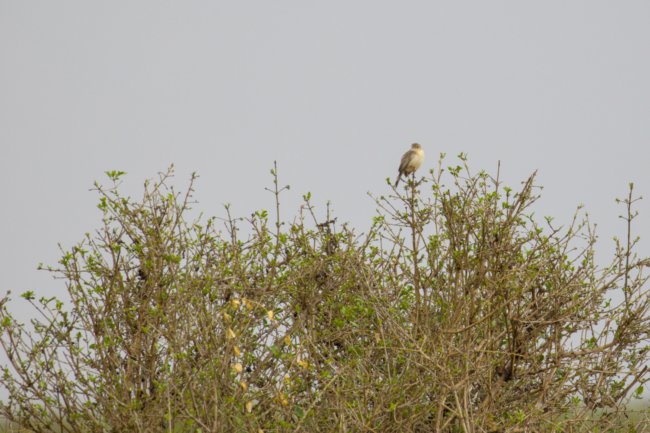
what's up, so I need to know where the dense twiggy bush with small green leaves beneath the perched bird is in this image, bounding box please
[0,156,650,432]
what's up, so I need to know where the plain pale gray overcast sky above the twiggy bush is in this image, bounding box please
[0,0,650,310]
